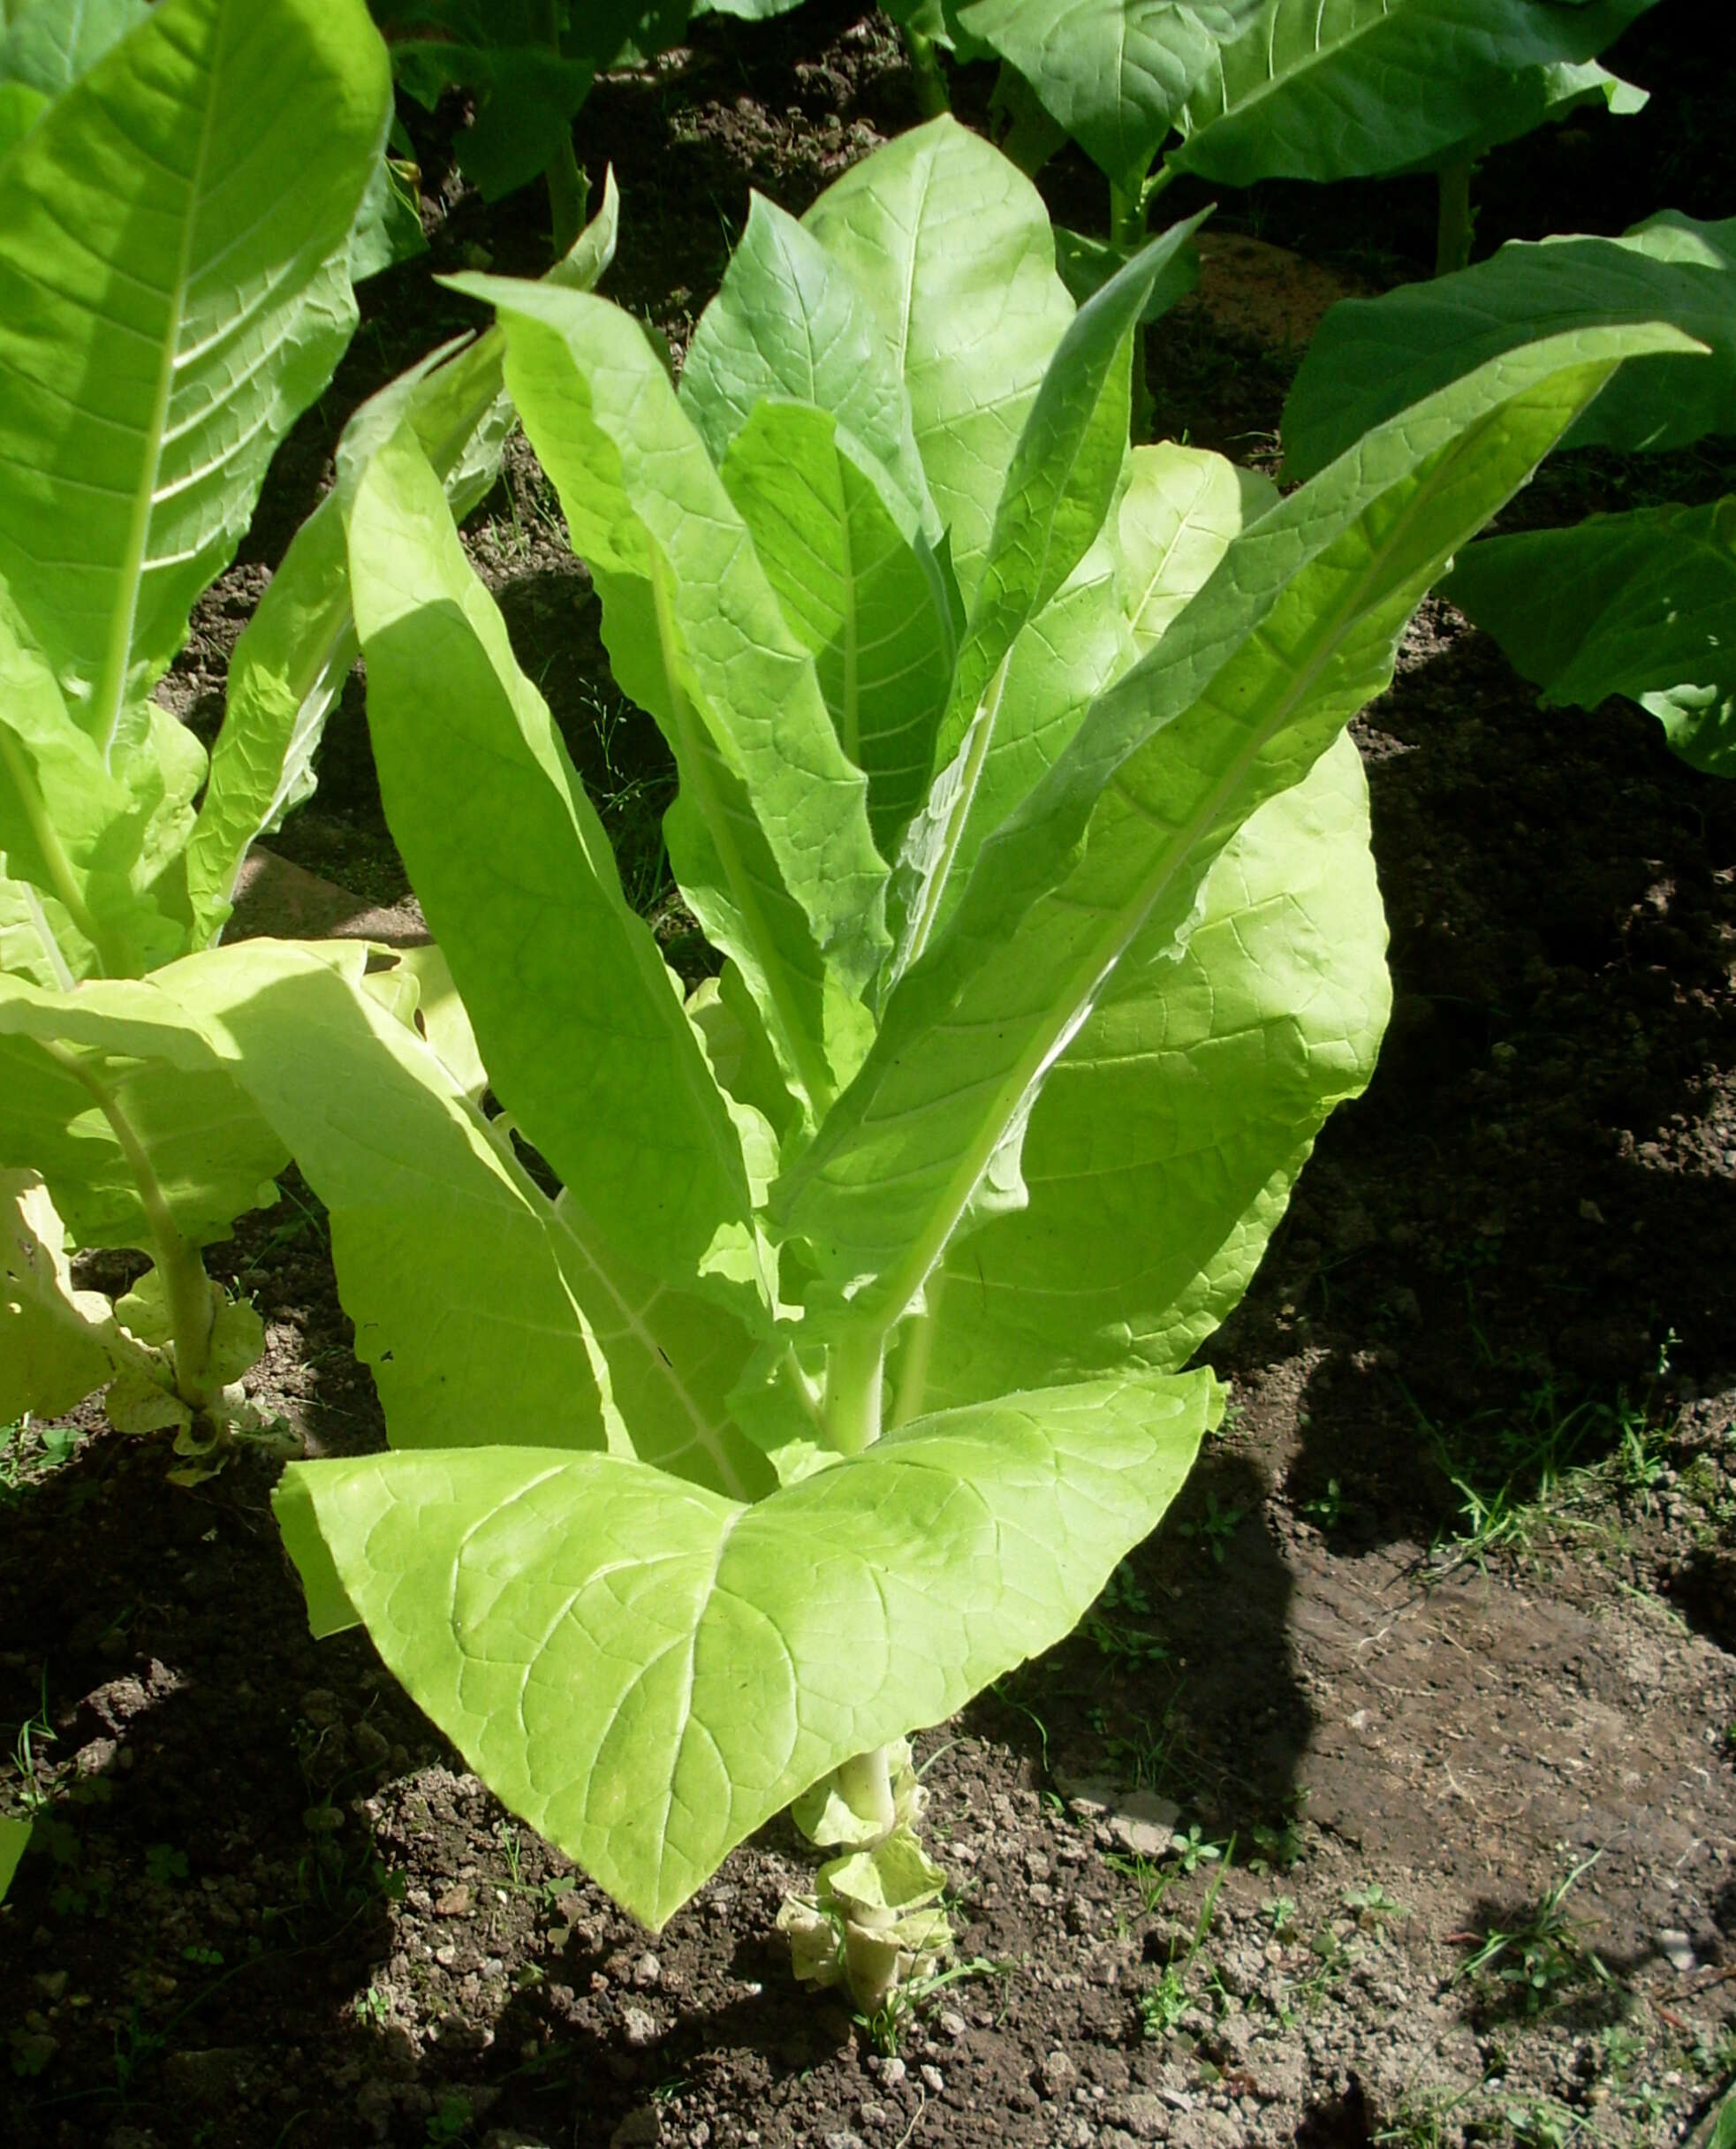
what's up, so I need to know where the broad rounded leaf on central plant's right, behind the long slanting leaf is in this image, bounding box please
[906,740,1390,1409]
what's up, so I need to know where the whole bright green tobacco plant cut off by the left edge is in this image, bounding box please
[0,0,612,1474]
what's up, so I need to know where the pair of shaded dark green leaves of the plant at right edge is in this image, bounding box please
[1283,210,1736,776]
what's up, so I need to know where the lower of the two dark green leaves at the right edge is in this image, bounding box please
[1442,497,1736,776]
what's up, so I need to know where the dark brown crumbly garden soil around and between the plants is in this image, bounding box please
[0,6,1736,2149]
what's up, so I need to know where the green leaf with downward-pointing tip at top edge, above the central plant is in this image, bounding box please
[959,0,1262,194]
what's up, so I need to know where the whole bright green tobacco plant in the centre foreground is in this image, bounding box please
[153,120,1685,2005]
